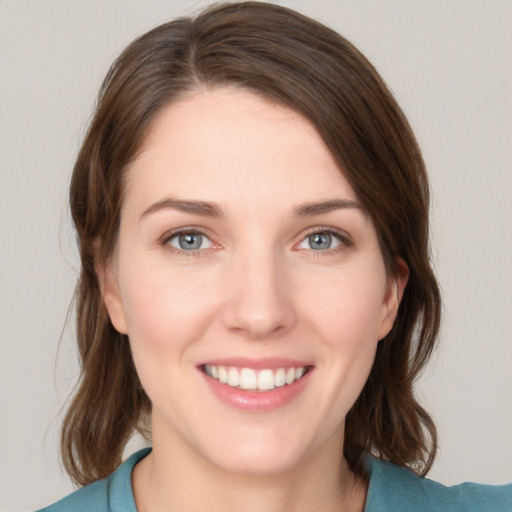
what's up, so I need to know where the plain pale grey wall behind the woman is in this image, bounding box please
[0,0,512,512]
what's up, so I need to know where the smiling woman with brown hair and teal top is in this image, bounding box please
[38,3,512,512]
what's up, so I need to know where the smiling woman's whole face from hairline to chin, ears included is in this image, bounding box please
[102,88,402,473]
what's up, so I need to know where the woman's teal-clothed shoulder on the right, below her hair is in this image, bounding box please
[365,456,512,512]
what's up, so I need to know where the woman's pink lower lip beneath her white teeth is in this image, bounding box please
[200,369,313,412]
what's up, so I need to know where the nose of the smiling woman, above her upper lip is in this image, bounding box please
[223,248,296,340]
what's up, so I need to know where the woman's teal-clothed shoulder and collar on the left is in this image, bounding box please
[33,448,150,512]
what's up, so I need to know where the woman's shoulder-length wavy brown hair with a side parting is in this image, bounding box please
[61,2,441,484]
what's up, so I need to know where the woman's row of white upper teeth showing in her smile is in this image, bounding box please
[204,364,306,391]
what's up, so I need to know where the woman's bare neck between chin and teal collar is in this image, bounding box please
[132,422,367,512]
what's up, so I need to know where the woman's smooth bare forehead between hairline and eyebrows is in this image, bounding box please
[125,87,356,215]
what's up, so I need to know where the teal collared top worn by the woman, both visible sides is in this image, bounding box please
[39,448,512,512]
